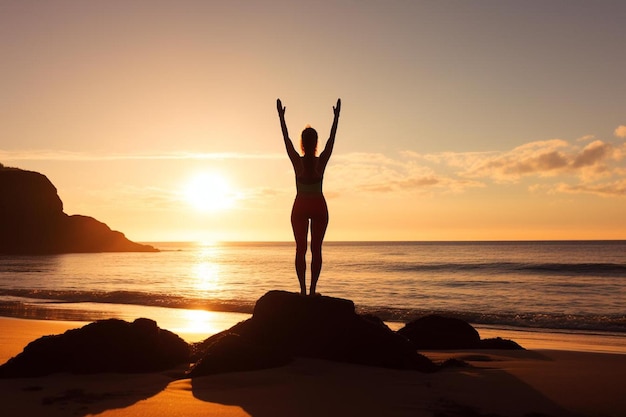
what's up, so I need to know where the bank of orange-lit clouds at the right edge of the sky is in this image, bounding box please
[402,134,626,197]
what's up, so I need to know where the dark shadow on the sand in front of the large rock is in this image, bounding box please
[191,359,571,417]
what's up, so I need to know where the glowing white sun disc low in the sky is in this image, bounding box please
[183,172,236,212]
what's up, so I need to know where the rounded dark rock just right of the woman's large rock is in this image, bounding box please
[398,315,480,349]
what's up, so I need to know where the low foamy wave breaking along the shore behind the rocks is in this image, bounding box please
[0,289,626,336]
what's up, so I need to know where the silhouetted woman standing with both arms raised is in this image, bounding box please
[276,99,341,295]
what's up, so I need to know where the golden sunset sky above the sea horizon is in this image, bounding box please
[0,0,626,242]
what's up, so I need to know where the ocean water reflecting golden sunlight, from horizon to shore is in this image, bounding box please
[0,241,626,352]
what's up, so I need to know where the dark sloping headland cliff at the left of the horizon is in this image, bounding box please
[0,164,157,254]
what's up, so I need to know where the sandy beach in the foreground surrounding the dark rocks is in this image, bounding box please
[0,318,626,417]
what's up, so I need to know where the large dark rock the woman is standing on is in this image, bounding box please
[190,291,437,376]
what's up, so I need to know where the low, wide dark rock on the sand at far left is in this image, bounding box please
[0,319,190,378]
